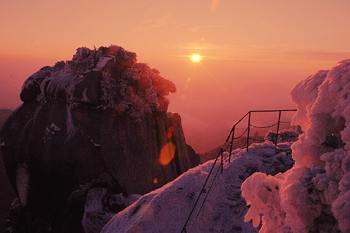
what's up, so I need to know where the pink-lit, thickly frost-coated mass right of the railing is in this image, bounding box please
[242,60,350,233]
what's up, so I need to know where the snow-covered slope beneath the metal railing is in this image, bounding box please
[102,142,293,233]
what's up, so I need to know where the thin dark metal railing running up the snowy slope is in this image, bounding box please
[181,109,297,233]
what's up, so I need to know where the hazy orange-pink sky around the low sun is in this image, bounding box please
[0,0,350,151]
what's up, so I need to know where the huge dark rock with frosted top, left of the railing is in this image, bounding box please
[1,46,199,232]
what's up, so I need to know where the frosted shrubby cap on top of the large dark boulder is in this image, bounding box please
[21,46,176,119]
